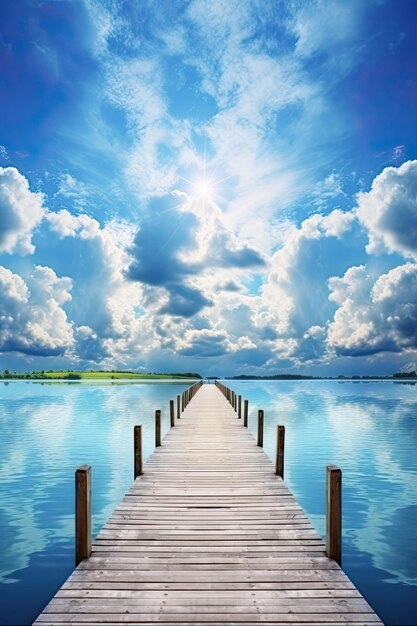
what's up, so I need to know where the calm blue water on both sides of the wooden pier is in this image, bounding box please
[0,381,417,626]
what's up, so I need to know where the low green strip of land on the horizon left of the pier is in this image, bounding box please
[0,369,201,380]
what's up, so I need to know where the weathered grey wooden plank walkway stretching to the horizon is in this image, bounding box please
[35,385,381,626]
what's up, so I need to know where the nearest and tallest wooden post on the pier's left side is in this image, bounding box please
[75,465,91,565]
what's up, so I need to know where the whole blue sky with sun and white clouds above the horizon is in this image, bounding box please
[0,0,417,376]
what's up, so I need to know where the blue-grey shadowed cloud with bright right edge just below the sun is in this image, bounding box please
[128,193,265,317]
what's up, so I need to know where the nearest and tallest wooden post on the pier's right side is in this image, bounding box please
[326,465,342,565]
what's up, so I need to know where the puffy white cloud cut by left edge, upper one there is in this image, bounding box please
[0,167,46,254]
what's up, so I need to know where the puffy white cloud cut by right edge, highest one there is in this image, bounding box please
[357,161,417,259]
